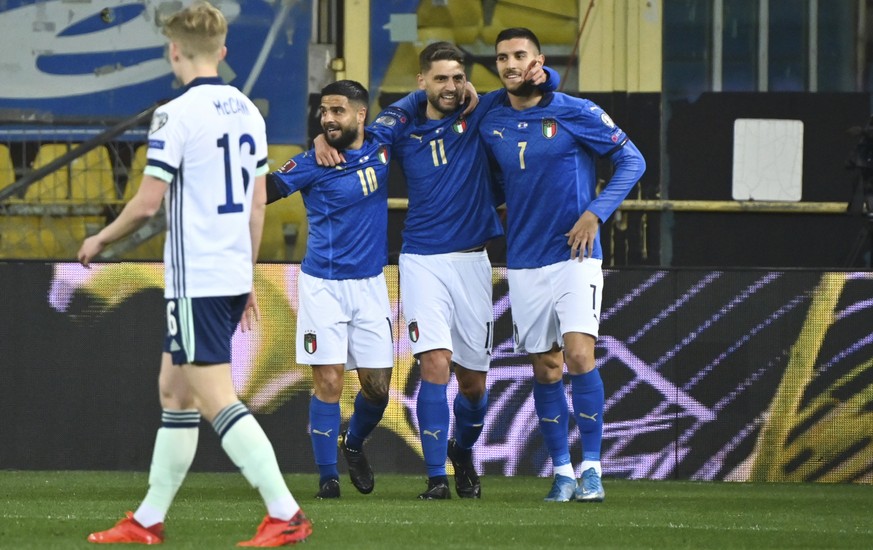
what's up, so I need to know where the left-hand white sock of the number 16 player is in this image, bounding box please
[133,410,200,527]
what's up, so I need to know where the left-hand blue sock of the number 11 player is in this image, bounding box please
[416,380,449,477]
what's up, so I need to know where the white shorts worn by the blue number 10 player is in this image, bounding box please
[296,272,394,370]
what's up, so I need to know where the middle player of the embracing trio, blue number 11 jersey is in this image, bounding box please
[316,42,559,500]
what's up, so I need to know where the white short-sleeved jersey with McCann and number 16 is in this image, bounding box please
[144,77,268,298]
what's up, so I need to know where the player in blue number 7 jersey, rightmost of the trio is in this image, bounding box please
[479,28,645,502]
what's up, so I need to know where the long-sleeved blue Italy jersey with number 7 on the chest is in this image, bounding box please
[479,93,645,269]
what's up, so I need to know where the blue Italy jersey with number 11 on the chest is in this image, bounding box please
[368,92,503,254]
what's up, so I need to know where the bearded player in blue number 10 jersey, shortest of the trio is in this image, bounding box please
[267,80,394,504]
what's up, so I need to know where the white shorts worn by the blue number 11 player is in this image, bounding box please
[399,250,494,371]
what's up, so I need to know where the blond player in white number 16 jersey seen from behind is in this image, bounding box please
[78,2,312,547]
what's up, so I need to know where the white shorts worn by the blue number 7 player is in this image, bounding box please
[507,258,603,353]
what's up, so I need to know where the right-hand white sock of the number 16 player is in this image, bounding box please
[216,405,300,520]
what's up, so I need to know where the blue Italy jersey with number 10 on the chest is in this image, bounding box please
[273,135,389,280]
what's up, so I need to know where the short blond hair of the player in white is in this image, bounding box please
[161,1,227,59]
